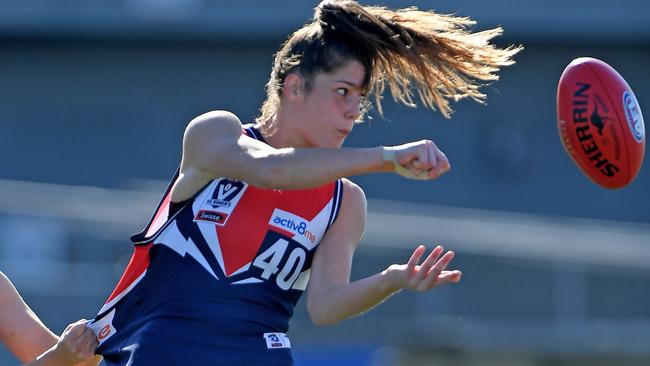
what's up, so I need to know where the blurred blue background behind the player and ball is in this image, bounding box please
[0,0,650,366]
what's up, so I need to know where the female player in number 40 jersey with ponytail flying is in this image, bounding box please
[88,0,519,366]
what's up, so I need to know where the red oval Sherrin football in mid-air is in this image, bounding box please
[557,57,645,189]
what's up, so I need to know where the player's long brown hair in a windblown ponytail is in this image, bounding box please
[257,0,522,127]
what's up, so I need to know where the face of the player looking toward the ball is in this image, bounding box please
[290,60,366,147]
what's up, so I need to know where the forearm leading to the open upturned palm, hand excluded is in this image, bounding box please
[308,271,400,325]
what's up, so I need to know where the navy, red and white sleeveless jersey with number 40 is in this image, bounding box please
[90,125,342,366]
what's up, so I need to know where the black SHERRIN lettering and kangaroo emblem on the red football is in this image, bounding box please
[573,82,620,177]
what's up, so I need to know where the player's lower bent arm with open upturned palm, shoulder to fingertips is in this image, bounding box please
[307,180,461,325]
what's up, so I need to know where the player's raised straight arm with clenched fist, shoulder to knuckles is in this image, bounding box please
[172,111,449,201]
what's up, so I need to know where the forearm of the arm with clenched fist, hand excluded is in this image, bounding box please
[249,147,393,189]
